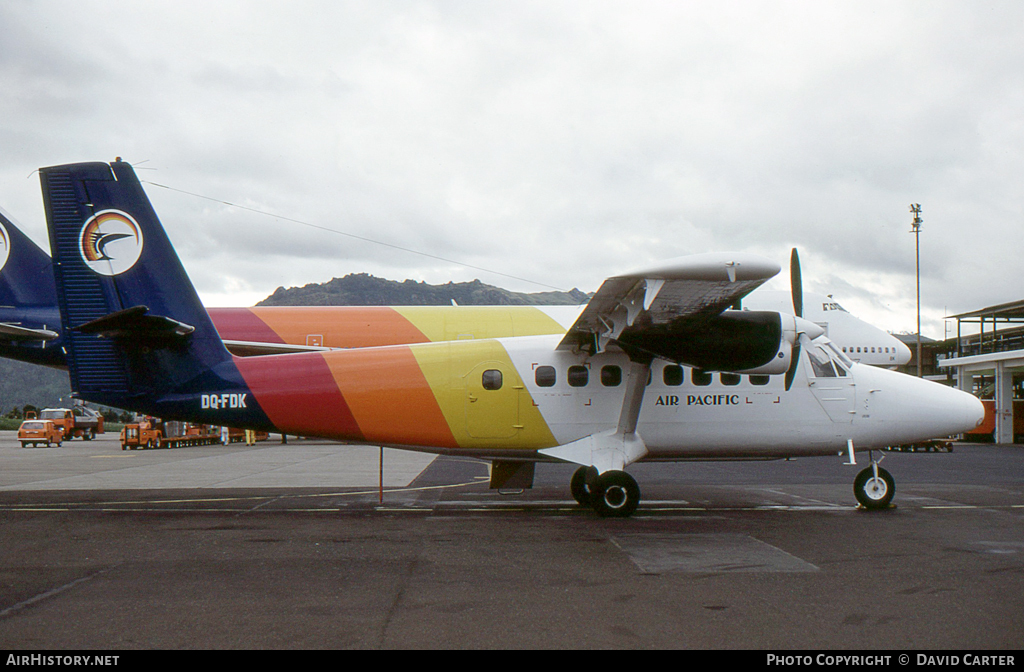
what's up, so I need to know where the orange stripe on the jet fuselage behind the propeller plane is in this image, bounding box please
[242,306,430,347]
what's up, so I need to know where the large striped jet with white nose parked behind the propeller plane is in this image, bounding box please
[0,212,910,367]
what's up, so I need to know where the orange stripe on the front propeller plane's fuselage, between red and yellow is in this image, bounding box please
[323,346,458,448]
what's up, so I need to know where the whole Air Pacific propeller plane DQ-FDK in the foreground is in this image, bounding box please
[41,161,984,516]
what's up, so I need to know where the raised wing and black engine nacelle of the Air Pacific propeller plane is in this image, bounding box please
[558,253,781,369]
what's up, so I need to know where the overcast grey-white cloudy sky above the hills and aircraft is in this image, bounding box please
[0,0,1024,338]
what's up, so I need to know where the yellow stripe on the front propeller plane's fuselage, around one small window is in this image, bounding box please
[411,342,556,451]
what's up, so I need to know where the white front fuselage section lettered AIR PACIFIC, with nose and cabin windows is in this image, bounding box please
[501,336,984,460]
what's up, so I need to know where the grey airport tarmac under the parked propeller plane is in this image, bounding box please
[0,432,1024,661]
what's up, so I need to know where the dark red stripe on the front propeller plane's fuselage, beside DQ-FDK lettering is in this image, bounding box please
[234,352,362,442]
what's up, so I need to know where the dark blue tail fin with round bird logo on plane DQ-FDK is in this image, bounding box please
[40,160,241,417]
